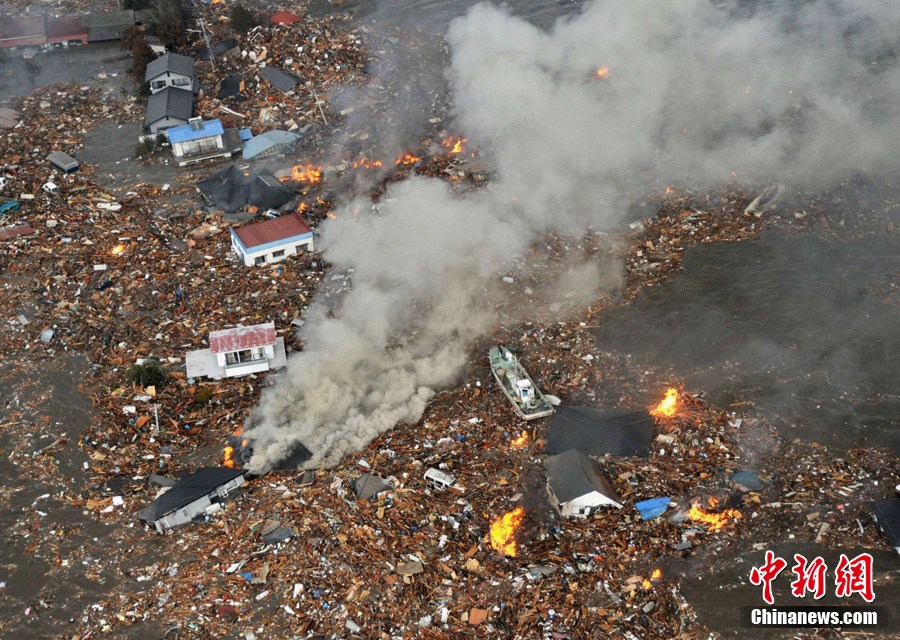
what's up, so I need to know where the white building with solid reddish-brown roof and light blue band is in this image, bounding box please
[231,212,315,267]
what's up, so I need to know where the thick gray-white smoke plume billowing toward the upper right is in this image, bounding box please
[248,0,900,471]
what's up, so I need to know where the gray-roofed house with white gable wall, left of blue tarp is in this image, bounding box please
[546,449,622,518]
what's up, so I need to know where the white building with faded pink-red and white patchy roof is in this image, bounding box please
[185,322,287,380]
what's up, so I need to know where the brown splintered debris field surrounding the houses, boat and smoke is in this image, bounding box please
[0,2,900,639]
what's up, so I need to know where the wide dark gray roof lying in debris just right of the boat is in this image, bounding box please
[544,407,653,456]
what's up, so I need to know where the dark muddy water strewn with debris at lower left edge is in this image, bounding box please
[0,356,160,640]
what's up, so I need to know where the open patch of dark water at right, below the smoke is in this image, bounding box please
[596,233,900,451]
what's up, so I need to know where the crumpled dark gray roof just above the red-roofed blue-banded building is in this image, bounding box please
[197,165,294,211]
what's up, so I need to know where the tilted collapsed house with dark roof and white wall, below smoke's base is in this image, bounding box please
[138,467,245,533]
